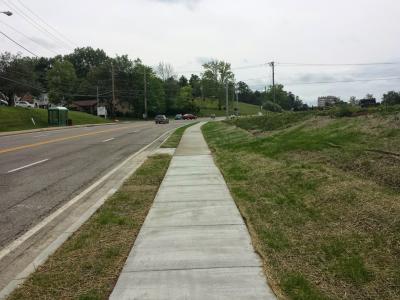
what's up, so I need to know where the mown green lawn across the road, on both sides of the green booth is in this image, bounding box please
[0,106,109,132]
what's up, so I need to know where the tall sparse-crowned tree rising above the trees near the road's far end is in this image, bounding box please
[202,60,235,110]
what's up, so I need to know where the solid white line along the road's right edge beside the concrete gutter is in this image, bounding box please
[0,126,177,260]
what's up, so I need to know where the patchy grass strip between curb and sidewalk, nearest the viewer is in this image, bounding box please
[9,155,171,300]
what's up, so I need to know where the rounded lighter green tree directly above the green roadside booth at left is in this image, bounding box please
[47,60,77,103]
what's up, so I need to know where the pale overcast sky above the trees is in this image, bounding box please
[0,0,400,105]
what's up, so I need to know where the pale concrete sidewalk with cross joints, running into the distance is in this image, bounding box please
[110,123,276,300]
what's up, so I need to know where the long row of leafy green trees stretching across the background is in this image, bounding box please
[0,47,307,117]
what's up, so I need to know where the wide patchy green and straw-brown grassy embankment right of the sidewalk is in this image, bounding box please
[203,109,400,300]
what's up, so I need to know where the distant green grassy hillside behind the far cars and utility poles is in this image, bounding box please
[195,99,265,117]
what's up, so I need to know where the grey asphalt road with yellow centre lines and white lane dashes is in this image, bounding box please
[0,121,192,249]
